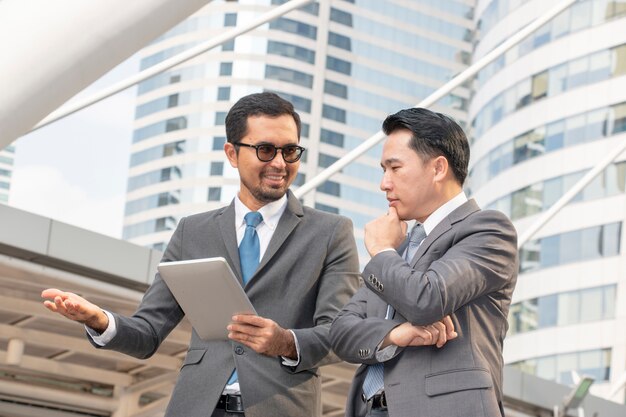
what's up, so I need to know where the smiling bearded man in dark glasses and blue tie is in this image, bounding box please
[42,93,359,417]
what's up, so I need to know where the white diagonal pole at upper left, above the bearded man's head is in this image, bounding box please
[31,0,313,132]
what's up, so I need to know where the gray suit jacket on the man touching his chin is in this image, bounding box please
[330,200,518,417]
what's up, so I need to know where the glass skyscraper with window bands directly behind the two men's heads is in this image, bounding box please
[124,0,473,259]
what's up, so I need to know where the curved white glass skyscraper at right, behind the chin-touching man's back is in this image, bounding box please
[469,0,626,403]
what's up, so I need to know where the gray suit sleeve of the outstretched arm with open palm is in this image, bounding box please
[89,219,185,359]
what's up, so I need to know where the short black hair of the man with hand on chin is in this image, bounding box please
[383,107,470,185]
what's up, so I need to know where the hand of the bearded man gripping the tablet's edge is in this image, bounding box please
[227,314,298,359]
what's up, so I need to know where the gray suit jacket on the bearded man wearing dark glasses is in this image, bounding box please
[91,192,359,417]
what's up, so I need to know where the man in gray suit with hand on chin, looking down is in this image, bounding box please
[330,108,518,417]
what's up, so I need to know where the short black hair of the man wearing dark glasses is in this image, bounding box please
[226,92,301,143]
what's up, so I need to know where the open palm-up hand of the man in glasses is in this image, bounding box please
[41,288,109,333]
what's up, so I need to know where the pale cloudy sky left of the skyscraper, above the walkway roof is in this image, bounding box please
[9,56,139,238]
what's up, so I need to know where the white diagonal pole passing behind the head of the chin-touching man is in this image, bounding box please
[294,0,576,198]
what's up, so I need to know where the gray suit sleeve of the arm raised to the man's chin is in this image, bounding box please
[363,211,518,325]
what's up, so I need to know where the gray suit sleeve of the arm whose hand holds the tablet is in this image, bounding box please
[288,217,359,372]
